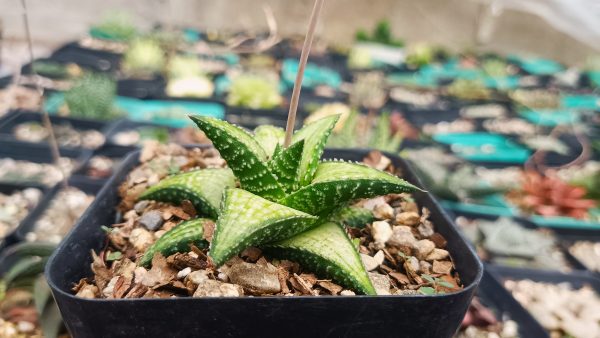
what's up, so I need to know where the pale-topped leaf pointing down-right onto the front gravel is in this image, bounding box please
[262,222,376,295]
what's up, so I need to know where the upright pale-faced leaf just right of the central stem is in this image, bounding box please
[292,115,339,187]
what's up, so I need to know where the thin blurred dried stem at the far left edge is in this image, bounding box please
[21,0,67,186]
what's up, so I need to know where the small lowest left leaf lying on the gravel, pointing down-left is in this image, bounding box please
[138,218,212,266]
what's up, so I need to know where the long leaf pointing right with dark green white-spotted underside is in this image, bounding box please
[279,161,420,215]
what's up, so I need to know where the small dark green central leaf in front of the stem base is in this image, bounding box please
[269,140,304,194]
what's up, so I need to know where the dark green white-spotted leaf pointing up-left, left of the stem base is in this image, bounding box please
[190,116,285,200]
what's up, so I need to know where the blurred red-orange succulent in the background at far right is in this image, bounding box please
[508,171,596,219]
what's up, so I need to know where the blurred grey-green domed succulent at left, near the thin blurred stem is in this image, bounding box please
[65,74,119,120]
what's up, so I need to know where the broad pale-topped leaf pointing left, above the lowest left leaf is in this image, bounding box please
[139,168,235,218]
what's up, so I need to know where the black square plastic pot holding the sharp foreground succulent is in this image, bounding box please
[46,150,483,337]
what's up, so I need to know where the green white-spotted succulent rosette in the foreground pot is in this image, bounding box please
[139,116,418,294]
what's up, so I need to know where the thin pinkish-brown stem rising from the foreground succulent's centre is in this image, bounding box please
[283,0,325,148]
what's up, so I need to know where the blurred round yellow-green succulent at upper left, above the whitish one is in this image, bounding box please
[121,38,166,77]
